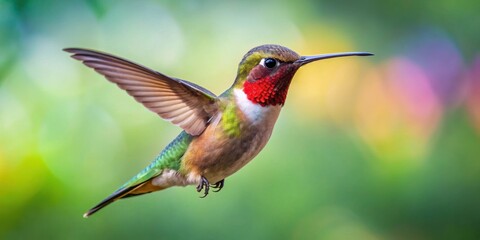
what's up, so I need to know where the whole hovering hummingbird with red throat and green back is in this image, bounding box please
[64,44,373,218]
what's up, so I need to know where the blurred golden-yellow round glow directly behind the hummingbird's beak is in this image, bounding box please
[290,23,372,124]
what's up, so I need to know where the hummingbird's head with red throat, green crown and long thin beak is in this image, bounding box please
[234,44,372,106]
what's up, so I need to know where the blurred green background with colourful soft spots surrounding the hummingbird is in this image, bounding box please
[0,0,480,239]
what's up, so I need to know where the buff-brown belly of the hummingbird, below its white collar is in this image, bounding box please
[183,104,280,183]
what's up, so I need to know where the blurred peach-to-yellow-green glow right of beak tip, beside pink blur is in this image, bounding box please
[355,62,438,172]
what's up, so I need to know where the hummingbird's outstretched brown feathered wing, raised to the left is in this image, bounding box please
[64,48,217,135]
